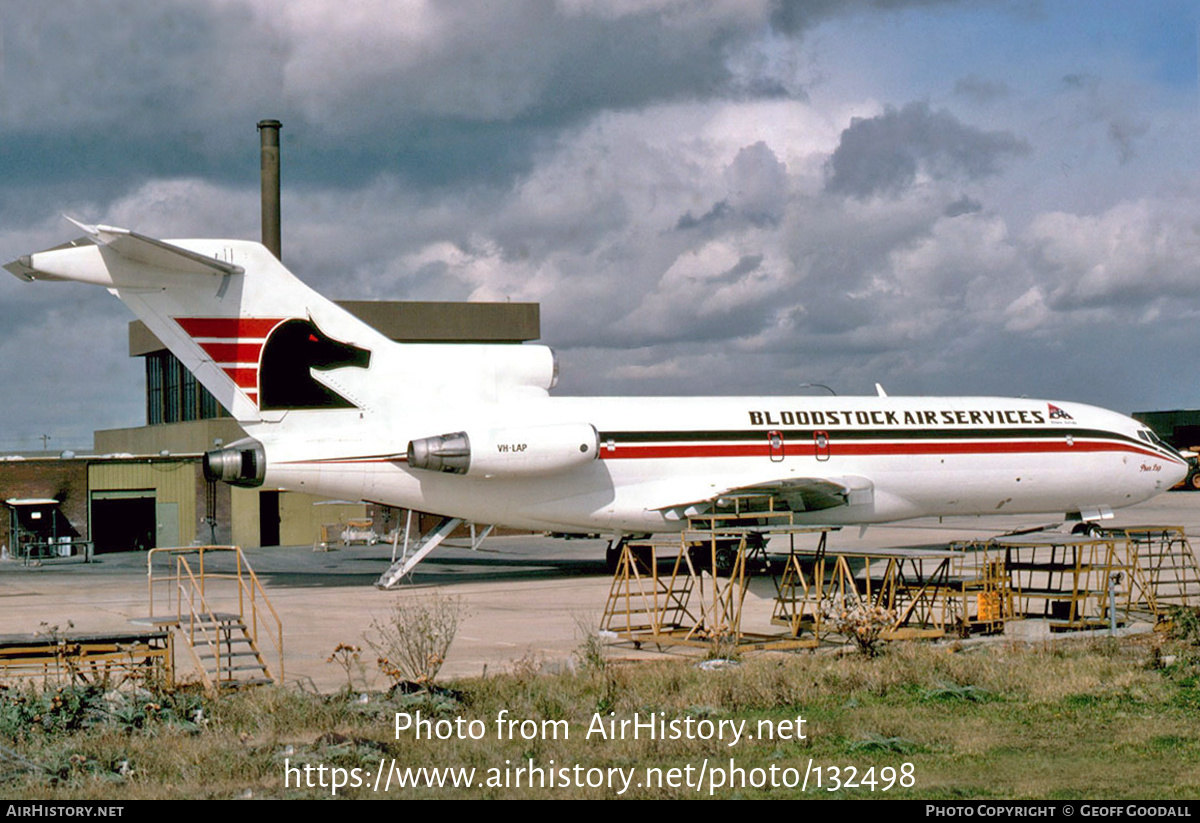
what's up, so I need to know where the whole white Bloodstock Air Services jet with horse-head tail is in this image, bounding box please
[5,223,1187,573]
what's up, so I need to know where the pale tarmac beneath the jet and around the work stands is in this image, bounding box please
[0,492,1200,691]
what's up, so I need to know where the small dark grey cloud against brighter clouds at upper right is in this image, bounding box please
[826,103,1030,198]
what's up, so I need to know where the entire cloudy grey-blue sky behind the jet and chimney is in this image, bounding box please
[0,0,1200,450]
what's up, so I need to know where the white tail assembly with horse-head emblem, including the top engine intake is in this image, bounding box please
[5,218,556,429]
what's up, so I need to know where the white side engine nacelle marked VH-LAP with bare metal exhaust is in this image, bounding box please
[408,423,600,477]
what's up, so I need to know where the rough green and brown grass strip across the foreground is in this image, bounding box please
[0,639,1200,799]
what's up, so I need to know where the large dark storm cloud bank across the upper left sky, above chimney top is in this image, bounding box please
[0,0,806,197]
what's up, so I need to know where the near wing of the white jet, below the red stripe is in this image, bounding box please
[655,475,875,519]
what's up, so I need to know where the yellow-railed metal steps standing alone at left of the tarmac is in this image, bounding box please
[146,546,283,693]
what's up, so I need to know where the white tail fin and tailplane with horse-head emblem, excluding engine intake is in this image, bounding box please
[5,218,391,422]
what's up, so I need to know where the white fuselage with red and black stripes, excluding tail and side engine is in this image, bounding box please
[250,397,1187,533]
